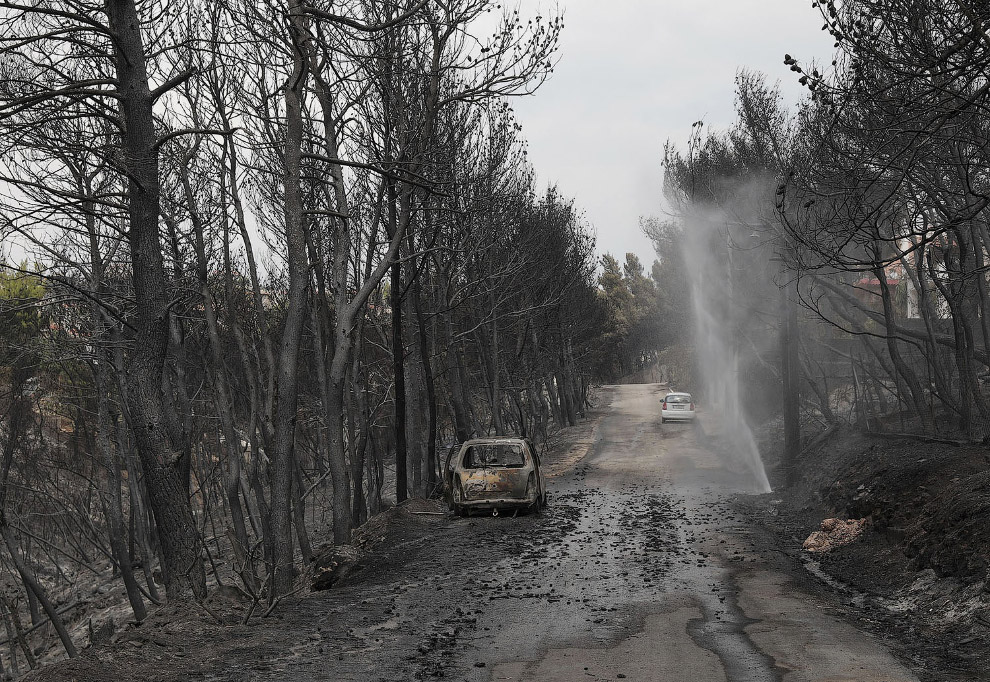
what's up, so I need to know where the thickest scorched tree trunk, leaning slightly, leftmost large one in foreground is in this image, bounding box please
[105,0,206,598]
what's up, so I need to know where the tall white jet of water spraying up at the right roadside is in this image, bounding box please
[678,180,778,493]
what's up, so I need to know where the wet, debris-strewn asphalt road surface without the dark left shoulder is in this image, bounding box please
[486,385,917,682]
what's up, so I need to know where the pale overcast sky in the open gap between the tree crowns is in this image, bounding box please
[513,0,832,269]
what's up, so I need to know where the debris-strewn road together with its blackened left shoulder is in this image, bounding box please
[202,385,917,682]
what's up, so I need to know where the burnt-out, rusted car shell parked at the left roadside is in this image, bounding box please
[444,437,547,515]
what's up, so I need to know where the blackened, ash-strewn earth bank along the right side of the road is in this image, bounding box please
[742,427,990,680]
